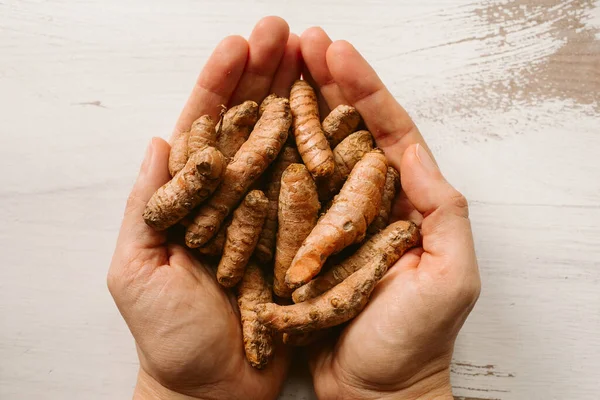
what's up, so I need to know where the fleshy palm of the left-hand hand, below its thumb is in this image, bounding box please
[114,246,285,399]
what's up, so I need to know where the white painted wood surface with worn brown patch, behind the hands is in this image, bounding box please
[0,0,600,400]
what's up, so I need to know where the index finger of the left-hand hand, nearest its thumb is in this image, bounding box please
[173,36,248,142]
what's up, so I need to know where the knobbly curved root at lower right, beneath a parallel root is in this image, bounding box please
[255,254,397,334]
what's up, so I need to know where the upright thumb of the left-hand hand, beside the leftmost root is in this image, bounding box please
[117,138,171,253]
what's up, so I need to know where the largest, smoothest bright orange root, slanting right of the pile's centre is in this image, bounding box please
[285,149,387,289]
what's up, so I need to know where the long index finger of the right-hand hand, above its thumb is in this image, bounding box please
[327,41,429,170]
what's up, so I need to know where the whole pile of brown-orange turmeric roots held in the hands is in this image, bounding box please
[143,80,420,368]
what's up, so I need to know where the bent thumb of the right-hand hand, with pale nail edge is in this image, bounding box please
[401,144,477,268]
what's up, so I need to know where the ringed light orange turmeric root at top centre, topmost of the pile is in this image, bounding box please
[290,80,334,179]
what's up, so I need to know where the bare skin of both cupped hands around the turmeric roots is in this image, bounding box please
[108,17,480,400]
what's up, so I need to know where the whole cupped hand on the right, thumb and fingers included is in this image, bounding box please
[300,28,481,399]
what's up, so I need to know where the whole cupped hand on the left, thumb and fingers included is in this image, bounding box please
[108,17,301,399]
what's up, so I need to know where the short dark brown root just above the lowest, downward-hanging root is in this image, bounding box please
[217,190,269,287]
